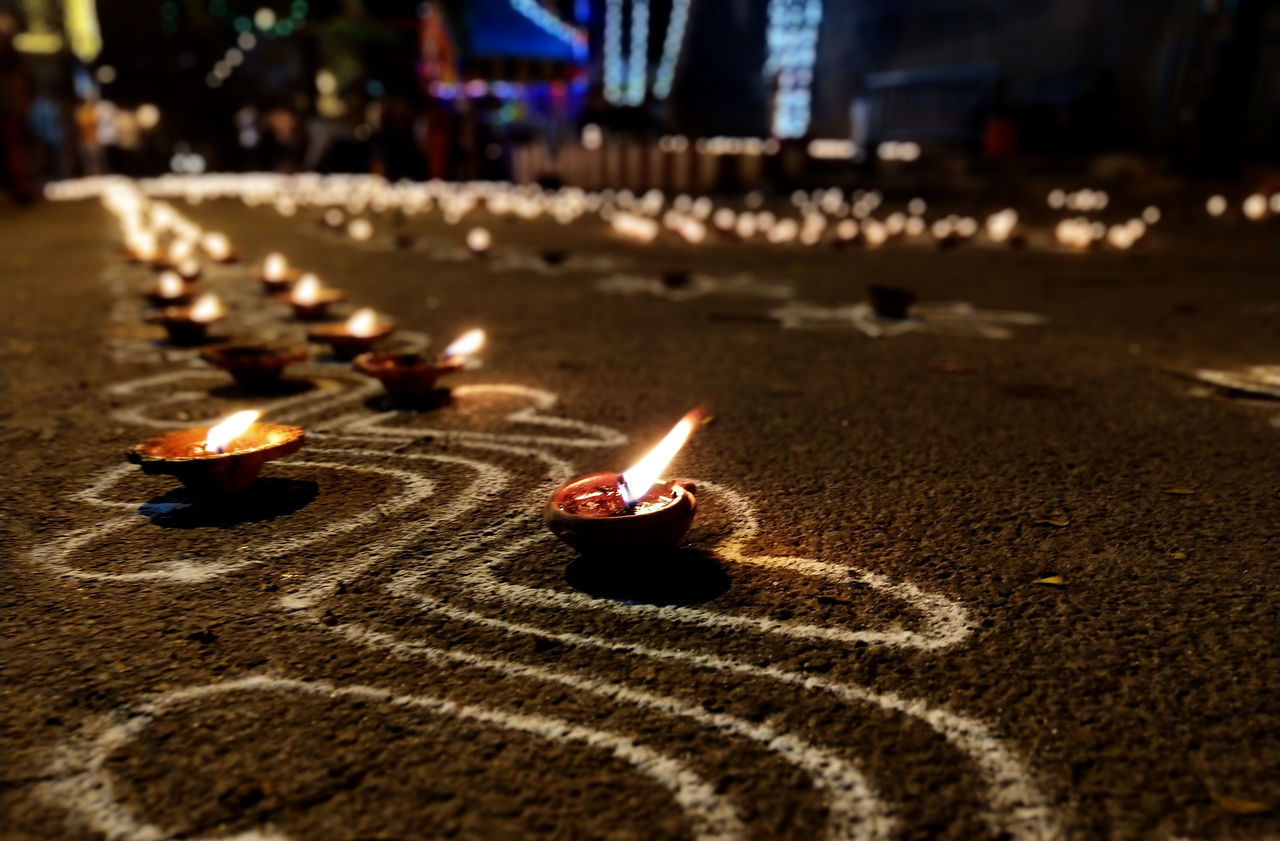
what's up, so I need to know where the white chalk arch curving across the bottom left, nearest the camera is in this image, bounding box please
[41,676,746,841]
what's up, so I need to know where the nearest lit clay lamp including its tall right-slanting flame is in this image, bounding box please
[543,408,703,556]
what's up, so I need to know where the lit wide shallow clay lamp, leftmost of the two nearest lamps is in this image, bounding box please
[128,411,305,497]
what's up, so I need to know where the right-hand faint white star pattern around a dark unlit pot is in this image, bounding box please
[769,301,1044,339]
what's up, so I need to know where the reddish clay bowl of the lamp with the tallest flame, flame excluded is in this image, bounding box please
[543,472,698,554]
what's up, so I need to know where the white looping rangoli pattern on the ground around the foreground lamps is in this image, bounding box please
[31,227,1062,841]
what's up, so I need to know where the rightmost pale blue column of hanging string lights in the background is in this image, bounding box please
[764,0,822,137]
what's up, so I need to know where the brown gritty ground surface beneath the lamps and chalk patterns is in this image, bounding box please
[0,193,1280,841]
